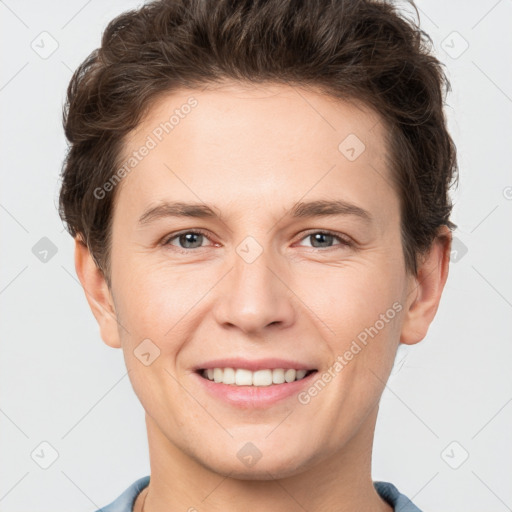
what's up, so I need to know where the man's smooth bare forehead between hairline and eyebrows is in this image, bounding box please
[118,83,394,228]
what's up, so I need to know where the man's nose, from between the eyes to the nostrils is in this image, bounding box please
[214,244,297,335]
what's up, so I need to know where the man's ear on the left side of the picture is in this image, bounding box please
[75,236,121,348]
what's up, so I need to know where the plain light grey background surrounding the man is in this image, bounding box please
[0,0,512,512]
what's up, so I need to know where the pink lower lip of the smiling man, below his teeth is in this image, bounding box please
[194,372,318,409]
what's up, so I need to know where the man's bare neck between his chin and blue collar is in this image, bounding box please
[133,406,393,512]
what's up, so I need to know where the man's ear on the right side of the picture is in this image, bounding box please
[400,226,452,345]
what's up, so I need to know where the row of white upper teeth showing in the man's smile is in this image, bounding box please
[202,368,307,387]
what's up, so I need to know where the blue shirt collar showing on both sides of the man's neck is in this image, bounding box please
[96,476,421,512]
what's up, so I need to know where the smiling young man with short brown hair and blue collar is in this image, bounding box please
[60,0,456,512]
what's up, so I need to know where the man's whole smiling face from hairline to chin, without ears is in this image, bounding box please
[90,84,422,479]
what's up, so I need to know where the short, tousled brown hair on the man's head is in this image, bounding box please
[59,0,458,286]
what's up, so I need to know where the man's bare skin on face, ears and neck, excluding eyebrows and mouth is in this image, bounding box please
[75,83,451,512]
